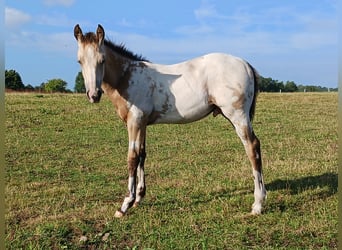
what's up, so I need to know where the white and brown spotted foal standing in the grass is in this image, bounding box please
[74,24,266,218]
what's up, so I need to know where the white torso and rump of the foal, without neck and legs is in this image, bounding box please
[121,53,254,124]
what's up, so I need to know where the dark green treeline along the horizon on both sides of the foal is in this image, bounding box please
[5,69,338,93]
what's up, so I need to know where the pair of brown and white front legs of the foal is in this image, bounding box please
[114,120,146,218]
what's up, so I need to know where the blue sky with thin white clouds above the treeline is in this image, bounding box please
[5,0,338,89]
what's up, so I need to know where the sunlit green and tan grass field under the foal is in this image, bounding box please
[5,93,338,249]
